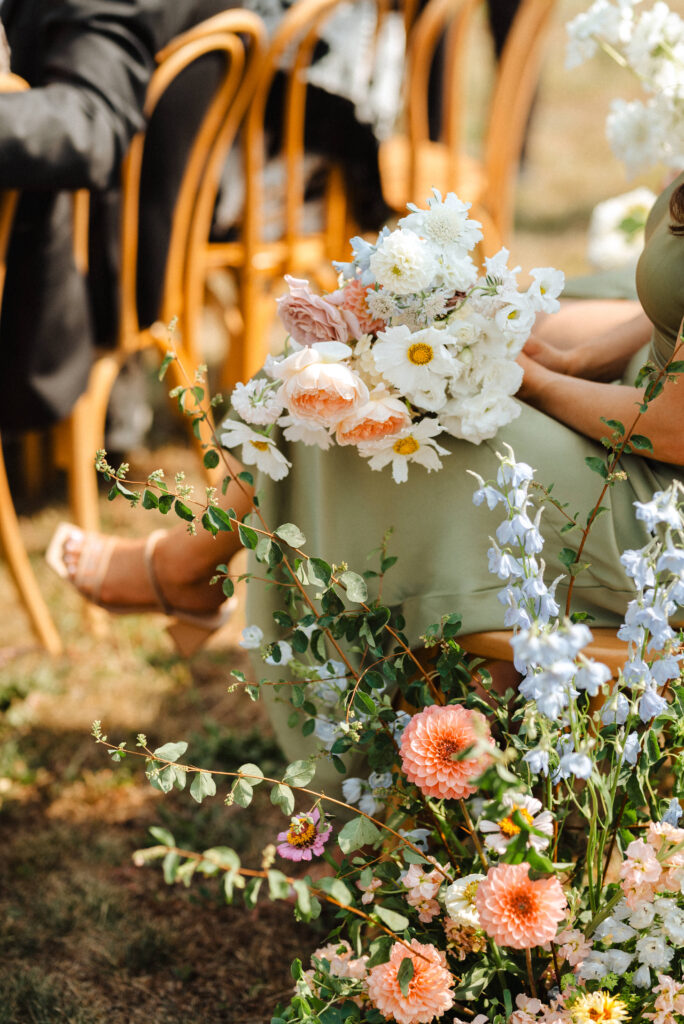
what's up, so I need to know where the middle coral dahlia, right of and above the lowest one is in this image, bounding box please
[475,862,567,949]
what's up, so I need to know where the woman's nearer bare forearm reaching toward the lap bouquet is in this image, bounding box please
[519,359,684,465]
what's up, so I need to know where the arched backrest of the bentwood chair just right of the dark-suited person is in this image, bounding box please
[120,9,264,348]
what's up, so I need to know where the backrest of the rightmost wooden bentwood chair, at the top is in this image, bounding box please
[405,0,554,243]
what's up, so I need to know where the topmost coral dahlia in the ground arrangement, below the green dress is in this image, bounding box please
[399,705,491,800]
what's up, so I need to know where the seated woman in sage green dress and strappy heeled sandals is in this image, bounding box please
[50,174,684,770]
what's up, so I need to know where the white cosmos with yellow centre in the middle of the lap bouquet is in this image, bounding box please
[373,325,458,394]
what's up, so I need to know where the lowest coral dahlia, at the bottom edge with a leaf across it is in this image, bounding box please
[367,939,454,1024]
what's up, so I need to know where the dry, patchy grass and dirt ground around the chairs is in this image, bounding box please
[0,0,658,1024]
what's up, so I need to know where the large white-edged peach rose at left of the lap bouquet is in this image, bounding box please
[277,346,369,427]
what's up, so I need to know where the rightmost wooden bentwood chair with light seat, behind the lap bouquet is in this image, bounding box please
[380,0,554,256]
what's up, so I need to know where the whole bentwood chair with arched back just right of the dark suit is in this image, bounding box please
[57,9,264,529]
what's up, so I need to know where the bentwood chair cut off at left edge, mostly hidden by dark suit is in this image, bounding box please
[0,74,61,654]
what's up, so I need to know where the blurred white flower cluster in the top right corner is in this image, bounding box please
[566,0,684,175]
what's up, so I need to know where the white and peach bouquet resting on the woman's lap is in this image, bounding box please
[221,189,563,483]
